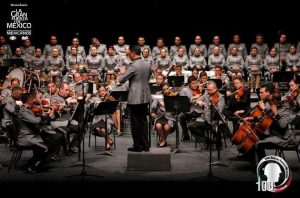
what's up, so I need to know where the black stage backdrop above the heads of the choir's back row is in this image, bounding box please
[0,0,300,51]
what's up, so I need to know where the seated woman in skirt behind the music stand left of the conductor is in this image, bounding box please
[91,85,115,149]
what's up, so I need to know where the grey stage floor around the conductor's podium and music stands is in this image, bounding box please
[0,122,300,195]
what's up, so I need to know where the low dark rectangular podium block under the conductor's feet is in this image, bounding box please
[127,147,171,171]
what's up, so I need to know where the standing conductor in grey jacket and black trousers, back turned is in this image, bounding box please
[119,46,151,152]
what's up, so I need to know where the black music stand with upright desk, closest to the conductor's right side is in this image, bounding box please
[164,96,190,154]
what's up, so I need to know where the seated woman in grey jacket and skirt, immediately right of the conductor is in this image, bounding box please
[151,84,177,147]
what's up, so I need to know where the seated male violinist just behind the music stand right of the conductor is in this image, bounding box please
[179,76,202,141]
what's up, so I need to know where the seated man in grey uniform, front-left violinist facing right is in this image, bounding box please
[17,94,48,174]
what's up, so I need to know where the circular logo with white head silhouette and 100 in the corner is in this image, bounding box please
[256,155,292,192]
